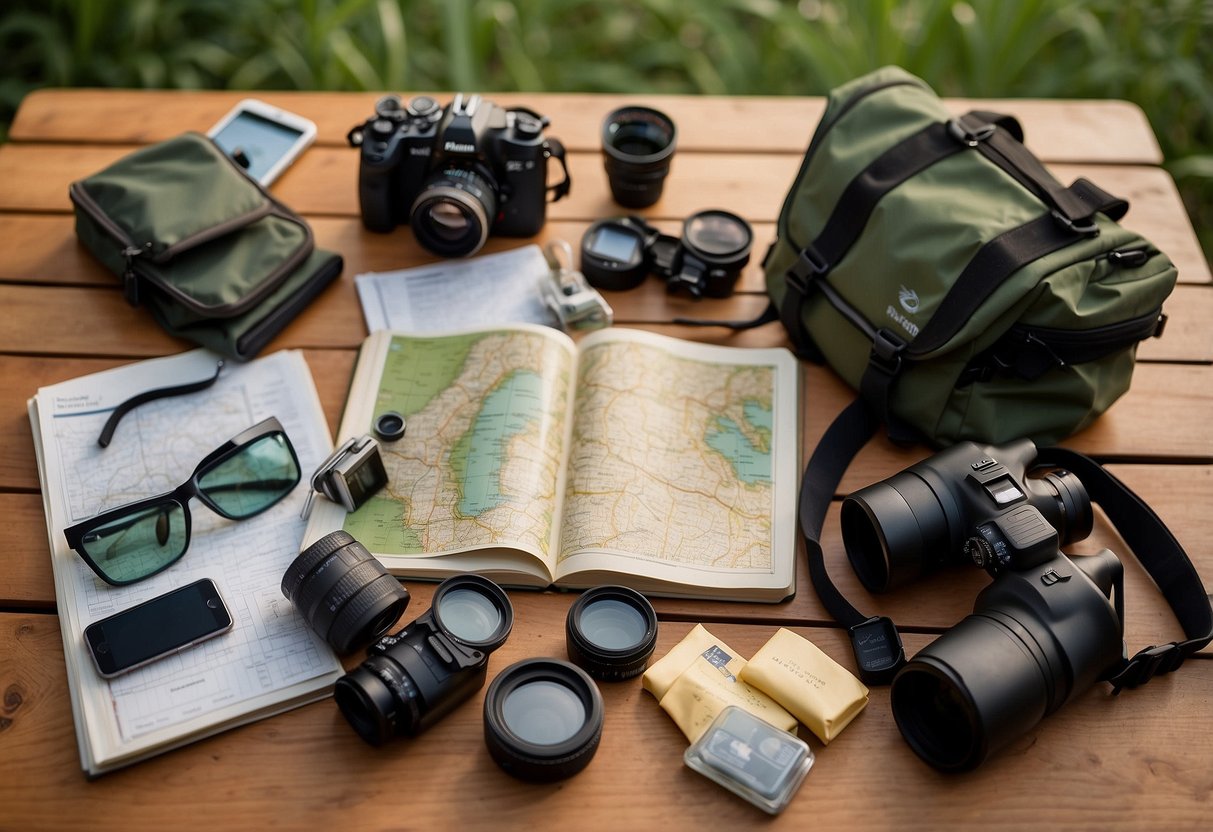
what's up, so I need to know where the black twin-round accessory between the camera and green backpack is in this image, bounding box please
[581,210,753,297]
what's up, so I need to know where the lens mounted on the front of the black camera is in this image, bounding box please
[410,167,497,257]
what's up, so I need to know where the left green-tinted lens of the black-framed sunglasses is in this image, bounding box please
[81,502,187,583]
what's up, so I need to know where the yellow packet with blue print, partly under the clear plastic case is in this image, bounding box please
[643,625,796,742]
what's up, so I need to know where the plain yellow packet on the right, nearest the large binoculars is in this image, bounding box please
[739,628,867,745]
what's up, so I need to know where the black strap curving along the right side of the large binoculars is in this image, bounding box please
[1036,448,1213,694]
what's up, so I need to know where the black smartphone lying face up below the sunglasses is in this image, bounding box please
[84,577,232,679]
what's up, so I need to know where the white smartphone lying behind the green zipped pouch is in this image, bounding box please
[206,98,315,187]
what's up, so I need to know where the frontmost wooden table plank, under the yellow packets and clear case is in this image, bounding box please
[0,613,1213,831]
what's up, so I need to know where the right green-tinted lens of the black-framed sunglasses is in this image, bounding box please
[198,433,300,520]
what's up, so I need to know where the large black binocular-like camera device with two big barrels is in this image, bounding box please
[842,439,1124,771]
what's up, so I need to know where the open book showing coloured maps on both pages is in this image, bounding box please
[304,325,799,602]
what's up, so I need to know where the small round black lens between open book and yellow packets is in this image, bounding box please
[565,587,657,680]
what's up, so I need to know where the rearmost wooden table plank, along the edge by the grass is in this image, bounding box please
[10,90,1162,165]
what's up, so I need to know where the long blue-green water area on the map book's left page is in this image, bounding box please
[459,370,543,517]
